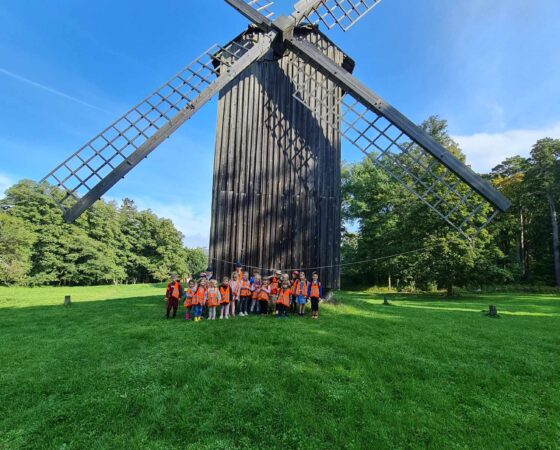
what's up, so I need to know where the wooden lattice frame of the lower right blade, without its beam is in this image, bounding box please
[291,54,499,239]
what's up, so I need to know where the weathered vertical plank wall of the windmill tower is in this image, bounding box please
[209,28,352,288]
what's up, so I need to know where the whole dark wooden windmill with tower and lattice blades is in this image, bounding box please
[42,0,510,288]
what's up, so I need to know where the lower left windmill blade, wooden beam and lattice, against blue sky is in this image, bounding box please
[41,32,276,222]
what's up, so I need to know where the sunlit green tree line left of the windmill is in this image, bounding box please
[0,180,207,285]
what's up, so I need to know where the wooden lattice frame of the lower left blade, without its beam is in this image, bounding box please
[41,39,255,211]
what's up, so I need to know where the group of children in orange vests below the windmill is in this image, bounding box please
[165,264,323,322]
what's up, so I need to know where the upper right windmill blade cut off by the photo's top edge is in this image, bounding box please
[292,0,381,31]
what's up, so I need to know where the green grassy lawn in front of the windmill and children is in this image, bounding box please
[0,285,560,450]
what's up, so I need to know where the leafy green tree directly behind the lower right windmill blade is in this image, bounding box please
[342,117,511,295]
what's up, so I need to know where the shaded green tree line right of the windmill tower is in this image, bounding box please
[342,117,560,294]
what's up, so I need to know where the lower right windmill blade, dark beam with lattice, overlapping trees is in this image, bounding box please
[288,38,511,237]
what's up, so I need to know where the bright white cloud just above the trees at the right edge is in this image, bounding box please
[453,123,560,173]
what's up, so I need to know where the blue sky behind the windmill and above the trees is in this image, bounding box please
[0,0,560,246]
